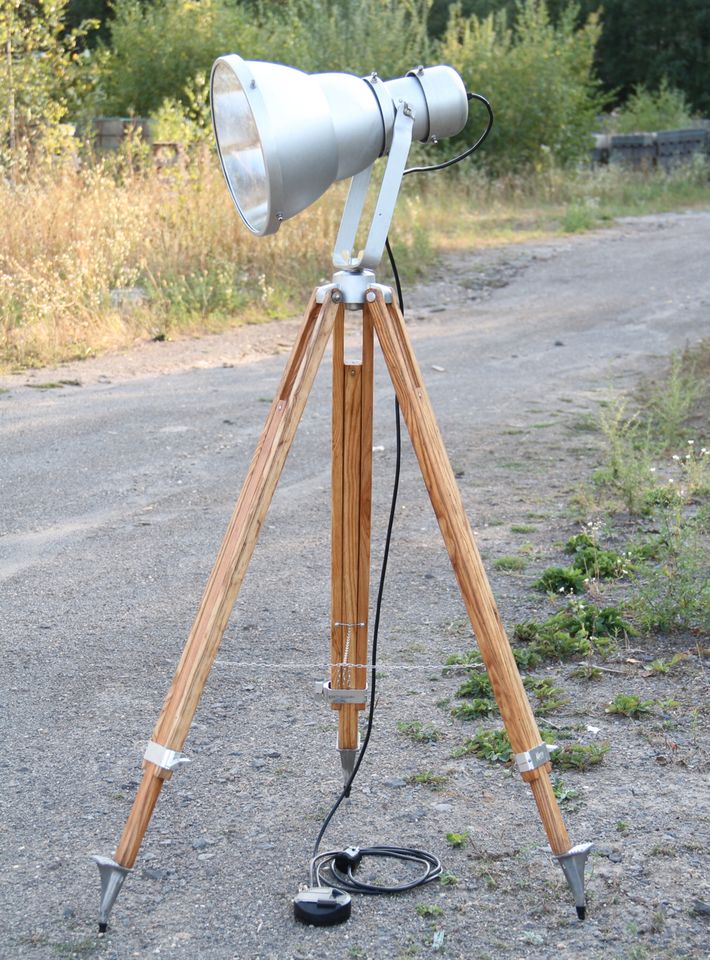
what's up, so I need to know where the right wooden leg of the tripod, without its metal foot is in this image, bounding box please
[365,291,570,855]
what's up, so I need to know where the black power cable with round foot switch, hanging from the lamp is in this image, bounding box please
[304,93,493,924]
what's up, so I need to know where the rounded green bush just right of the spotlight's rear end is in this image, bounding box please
[441,0,603,171]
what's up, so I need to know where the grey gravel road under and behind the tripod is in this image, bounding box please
[0,213,710,960]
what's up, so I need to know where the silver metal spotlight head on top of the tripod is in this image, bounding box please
[210,54,468,236]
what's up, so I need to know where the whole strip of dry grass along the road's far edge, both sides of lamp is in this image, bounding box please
[0,151,707,370]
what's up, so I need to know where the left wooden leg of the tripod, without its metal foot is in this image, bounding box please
[115,296,342,868]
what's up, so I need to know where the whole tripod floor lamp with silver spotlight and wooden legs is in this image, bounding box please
[95,54,591,930]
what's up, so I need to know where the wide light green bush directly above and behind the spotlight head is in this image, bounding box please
[103,0,431,116]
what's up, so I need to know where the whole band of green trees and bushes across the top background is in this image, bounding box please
[0,0,710,173]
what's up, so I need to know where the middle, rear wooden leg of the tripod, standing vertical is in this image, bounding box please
[331,315,373,764]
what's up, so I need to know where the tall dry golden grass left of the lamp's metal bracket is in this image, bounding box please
[0,151,337,368]
